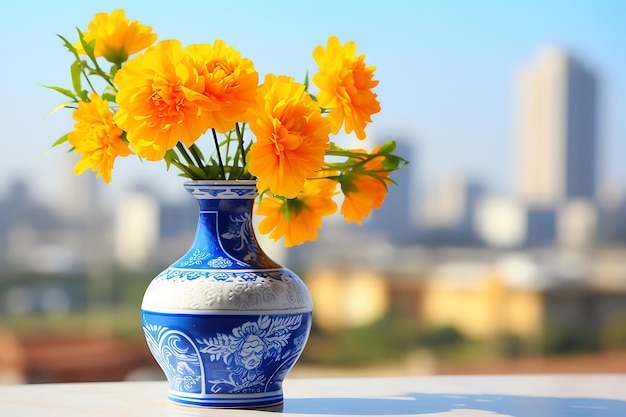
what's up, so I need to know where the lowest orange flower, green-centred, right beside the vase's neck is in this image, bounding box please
[255,179,338,247]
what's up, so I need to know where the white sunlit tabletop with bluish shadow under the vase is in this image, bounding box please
[0,375,626,417]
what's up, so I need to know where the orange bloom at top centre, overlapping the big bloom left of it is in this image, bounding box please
[183,39,259,133]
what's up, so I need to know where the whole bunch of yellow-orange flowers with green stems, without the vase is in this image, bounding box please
[46,10,407,246]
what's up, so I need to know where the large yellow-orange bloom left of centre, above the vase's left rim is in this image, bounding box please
[115,40,208,161]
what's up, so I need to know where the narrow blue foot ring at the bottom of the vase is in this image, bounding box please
[168,392,283,411]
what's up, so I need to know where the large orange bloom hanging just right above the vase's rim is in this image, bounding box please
[248,74,330,198]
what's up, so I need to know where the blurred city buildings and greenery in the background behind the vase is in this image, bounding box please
[0,47,626,382]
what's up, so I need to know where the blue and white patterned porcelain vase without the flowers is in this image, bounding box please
[141,181,312,408]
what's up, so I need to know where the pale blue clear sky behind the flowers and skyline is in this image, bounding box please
[0,0,626,203]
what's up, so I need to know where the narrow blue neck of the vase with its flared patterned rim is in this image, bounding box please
[172,181,280,270]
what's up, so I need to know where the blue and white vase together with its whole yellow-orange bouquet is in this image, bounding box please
[44,10,407,407]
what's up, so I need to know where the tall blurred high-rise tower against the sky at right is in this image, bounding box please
[517,47,598,208]
